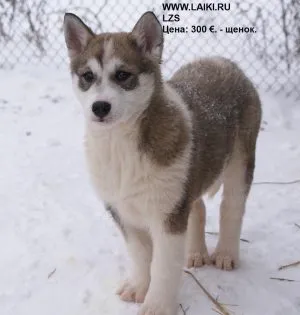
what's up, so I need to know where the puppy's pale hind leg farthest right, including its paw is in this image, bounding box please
[211,150,254,270]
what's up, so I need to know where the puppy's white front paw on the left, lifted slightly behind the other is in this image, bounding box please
[116,280,149,303]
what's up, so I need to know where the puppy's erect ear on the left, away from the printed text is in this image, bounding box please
[64,13,94,58]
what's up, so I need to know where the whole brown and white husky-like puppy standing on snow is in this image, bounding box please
[64,12,261,315]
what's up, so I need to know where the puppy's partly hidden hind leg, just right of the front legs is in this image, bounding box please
[187,199,210,268]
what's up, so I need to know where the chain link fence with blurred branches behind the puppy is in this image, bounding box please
[0,0,300,99]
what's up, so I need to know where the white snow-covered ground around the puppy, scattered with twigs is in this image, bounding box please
[0,68,300,315]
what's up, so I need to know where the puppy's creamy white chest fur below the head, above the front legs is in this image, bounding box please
[86,121,189,227]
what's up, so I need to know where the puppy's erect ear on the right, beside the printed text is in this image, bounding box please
[132,11,164,62]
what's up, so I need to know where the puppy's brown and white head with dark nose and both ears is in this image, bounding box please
[64,12,163,126]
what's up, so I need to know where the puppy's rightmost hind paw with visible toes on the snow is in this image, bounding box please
[211,248,239,270]
